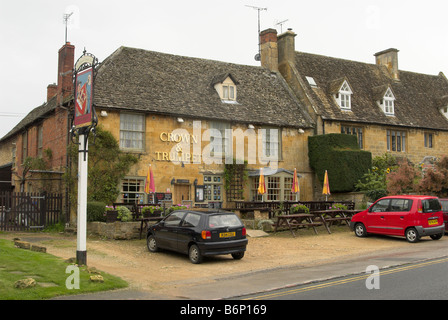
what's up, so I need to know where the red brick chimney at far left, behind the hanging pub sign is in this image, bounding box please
[57,42,75,104]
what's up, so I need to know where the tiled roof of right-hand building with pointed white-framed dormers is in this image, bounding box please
[295,52,448,130]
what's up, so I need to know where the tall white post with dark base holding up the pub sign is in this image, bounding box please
[76,134,88,265]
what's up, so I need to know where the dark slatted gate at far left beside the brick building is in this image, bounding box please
[0,192,62,231]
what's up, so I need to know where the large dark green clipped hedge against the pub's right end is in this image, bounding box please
[308,133,372,193]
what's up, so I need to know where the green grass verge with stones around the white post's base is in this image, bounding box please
[0,239,128,300]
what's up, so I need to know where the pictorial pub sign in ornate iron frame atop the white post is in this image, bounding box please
[73,51,98,129]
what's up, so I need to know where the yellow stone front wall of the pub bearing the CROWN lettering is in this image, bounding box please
[97,110,314,205]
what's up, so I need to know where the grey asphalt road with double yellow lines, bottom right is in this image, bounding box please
[242,258,448,300]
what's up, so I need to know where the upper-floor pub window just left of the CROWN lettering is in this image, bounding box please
[120,113,145,151]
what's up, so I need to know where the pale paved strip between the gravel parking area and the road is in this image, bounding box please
[57,238,448,300]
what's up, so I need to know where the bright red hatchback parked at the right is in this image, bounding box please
[350,195,445,242]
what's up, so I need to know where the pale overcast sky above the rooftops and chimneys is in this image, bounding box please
[0,0,448,137]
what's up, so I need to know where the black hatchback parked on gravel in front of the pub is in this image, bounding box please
[146,210,247,263]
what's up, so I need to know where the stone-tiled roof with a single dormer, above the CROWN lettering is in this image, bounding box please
[94,47,313,128]
